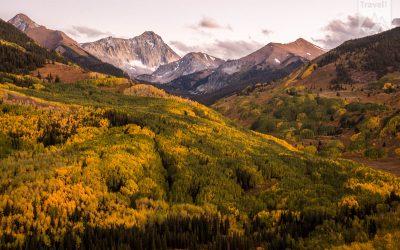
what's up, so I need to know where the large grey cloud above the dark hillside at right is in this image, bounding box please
[313,16,384,49]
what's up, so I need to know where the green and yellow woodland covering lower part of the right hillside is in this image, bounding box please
[248,90,400,159]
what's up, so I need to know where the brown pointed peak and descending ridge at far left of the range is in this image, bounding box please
[8,14,124,76]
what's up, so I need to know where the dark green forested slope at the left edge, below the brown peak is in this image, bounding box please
[0,19,66,74]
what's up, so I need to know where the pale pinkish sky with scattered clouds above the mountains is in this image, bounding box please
[0,0,400,59]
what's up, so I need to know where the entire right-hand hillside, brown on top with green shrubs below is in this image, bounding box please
[214,28,400,175]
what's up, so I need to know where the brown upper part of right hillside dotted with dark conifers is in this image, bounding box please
[293,27,400,90]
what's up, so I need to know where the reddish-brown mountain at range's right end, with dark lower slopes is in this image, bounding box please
[156,38,325,103]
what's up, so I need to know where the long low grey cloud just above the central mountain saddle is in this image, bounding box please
[170,40,263,60]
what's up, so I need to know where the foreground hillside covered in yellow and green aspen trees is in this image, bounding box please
[0,77,400,249]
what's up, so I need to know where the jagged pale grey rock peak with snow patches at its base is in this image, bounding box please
[82,31,180,77]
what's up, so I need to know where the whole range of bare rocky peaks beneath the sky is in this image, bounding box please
[9,14,325,103]
